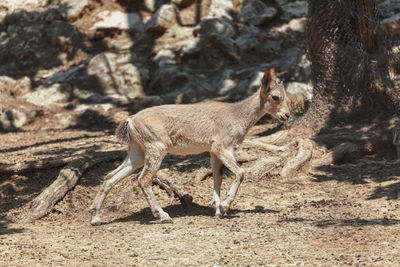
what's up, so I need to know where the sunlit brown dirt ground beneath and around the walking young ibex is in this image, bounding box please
[0,113,400,266]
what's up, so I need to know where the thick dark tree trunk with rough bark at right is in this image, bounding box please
[301,0,400,131]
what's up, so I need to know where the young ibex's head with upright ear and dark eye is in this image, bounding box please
[260,68,290,121]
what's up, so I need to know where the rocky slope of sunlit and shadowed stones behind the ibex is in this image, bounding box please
[0,0,400,131]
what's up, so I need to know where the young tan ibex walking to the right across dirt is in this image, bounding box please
[90,68,289,225]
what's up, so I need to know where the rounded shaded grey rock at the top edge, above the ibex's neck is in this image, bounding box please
[238,0,278,25]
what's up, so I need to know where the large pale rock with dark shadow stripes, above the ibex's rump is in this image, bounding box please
[87,52,149,99]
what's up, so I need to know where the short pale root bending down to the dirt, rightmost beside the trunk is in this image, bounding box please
[280,139,314,178]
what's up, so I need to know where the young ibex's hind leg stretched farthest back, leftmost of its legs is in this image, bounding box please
[89,143,144,225]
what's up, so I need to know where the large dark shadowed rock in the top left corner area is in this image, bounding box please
[0,9,84,77]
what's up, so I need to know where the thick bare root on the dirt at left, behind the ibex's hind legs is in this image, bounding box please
[23,151,125,222]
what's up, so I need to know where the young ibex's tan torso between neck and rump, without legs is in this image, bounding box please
[131,102,242,154]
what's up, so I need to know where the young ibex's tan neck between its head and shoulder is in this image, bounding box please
[234,90,266,133]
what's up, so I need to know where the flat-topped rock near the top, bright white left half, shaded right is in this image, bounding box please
[90,10,144,32]
